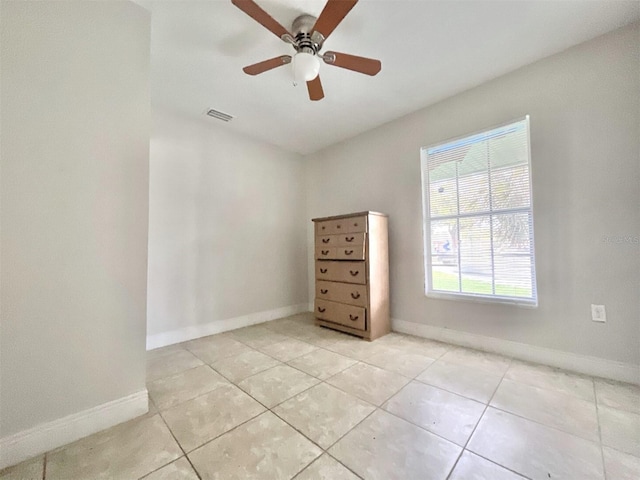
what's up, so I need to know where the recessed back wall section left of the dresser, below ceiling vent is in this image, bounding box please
[147,109,307,348]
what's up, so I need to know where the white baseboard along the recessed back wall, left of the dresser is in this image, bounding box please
[147,303,309,350]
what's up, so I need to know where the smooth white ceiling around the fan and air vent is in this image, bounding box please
[137,0,640,154]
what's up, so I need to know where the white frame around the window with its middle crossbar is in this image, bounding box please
[420,115,538,308]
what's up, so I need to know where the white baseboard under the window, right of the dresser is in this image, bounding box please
[391,318,640,384]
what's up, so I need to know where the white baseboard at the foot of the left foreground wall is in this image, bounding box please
[0,389,149,470]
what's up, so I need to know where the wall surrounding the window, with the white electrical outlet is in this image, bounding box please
[307,24,640,365]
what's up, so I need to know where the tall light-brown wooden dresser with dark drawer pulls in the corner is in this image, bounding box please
[313,212,391,340]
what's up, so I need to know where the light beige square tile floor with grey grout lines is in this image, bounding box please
[0,314,640,480]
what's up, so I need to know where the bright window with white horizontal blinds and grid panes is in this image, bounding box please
[421,116,537,305]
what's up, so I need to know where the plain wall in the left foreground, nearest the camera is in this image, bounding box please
[0,1,150,442]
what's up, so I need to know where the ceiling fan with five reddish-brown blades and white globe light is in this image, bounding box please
[231,0,382,100]
